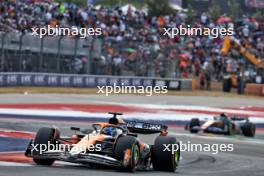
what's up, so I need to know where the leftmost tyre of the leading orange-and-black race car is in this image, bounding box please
[32,127,60,165]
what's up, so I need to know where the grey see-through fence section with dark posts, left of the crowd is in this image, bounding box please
[0,32,96,73]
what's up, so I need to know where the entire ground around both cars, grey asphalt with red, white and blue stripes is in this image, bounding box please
[0,94,264,176]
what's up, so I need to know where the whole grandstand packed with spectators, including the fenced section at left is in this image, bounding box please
[0,1,264,92]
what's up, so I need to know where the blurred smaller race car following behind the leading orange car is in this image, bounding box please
[185,113,256,137]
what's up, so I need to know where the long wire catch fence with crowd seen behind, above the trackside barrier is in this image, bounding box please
[0,31,180,78]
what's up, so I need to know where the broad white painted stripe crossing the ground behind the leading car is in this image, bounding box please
[0,108,264,123]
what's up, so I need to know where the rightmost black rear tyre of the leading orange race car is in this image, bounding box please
[151,136,180,172]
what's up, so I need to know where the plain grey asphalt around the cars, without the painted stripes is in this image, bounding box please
[0,94,264,176]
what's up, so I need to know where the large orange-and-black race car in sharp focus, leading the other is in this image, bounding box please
[25,113,180,172]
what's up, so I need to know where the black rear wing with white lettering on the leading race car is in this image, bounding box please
[126,121,168,134]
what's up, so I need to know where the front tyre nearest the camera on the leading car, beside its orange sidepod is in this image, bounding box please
[115,136,140,172]
